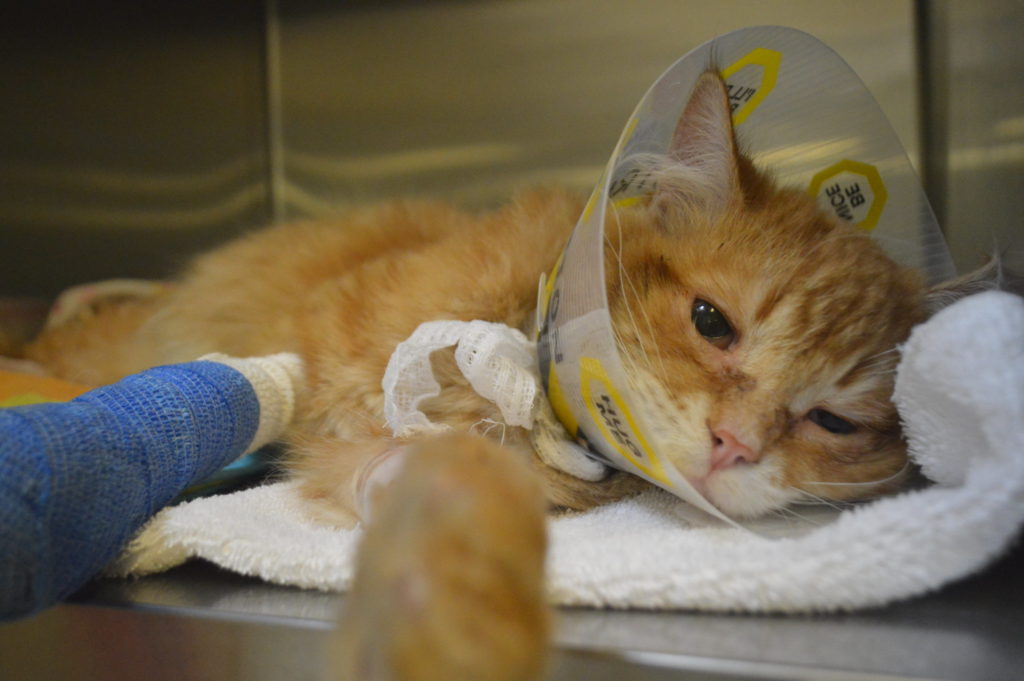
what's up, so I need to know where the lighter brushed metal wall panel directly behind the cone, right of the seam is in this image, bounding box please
[276,0,918,216]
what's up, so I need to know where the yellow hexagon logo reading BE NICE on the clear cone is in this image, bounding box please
[808,159,889,231]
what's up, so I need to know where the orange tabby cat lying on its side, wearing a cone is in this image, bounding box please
[19,73,970,679]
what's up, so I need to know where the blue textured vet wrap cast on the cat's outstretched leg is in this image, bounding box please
[0,361,259,619]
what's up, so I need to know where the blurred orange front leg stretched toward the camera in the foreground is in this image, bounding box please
[331,434,550,681]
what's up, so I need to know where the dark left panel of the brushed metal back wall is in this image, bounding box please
[0,0,268,296]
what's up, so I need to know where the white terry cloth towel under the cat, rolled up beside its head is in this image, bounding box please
[108,292,1024,612]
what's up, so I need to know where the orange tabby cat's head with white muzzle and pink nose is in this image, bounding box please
[605,72,950,516]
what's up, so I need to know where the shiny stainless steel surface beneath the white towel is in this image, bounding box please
[0,536,1024,681]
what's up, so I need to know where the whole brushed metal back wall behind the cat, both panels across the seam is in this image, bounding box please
[0,0,916,296]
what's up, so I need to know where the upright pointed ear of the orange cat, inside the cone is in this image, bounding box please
[654,71,741,214]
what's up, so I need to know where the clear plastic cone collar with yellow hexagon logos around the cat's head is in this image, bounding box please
[538,27,954,524]
